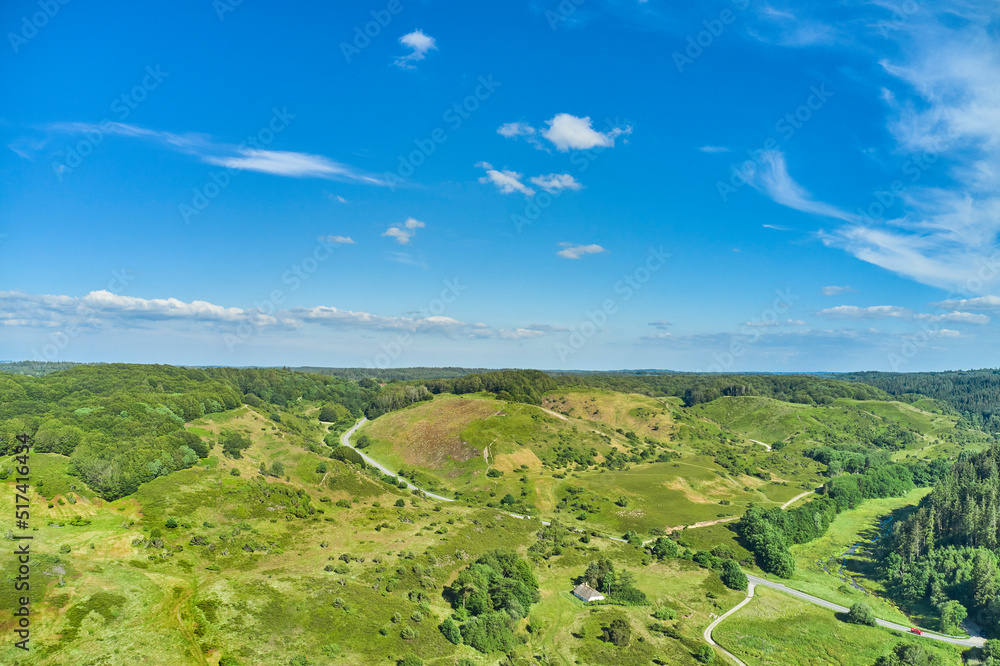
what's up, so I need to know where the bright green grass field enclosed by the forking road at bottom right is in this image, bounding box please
[712,587,962,666]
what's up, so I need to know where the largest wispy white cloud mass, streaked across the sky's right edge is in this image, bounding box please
[753,0,1000,294]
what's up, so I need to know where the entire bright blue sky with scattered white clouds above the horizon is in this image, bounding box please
[0,0,1000,372]
